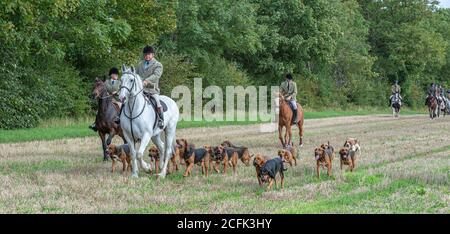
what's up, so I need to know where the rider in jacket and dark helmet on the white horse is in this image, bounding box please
[116,45,164,129]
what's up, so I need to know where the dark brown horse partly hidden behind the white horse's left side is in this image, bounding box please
[92,79,126,161]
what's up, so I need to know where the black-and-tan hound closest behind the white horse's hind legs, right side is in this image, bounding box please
[183,144,211,177]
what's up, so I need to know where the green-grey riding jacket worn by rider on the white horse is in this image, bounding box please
[136,59,163,94]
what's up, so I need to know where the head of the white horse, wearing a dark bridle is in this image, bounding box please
[119,65,143,102]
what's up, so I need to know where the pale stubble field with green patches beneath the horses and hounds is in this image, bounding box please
[0,115,450,214]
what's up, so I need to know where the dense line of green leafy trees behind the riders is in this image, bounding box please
[0,0,450,129]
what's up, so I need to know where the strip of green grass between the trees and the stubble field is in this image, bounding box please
[0,109,425,143]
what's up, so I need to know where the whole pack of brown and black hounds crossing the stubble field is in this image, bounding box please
[107,138,361,190]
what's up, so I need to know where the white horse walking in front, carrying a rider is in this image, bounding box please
[119,65,180,178]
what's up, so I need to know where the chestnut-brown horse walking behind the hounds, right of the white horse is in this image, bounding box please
[278,95,304,147]
